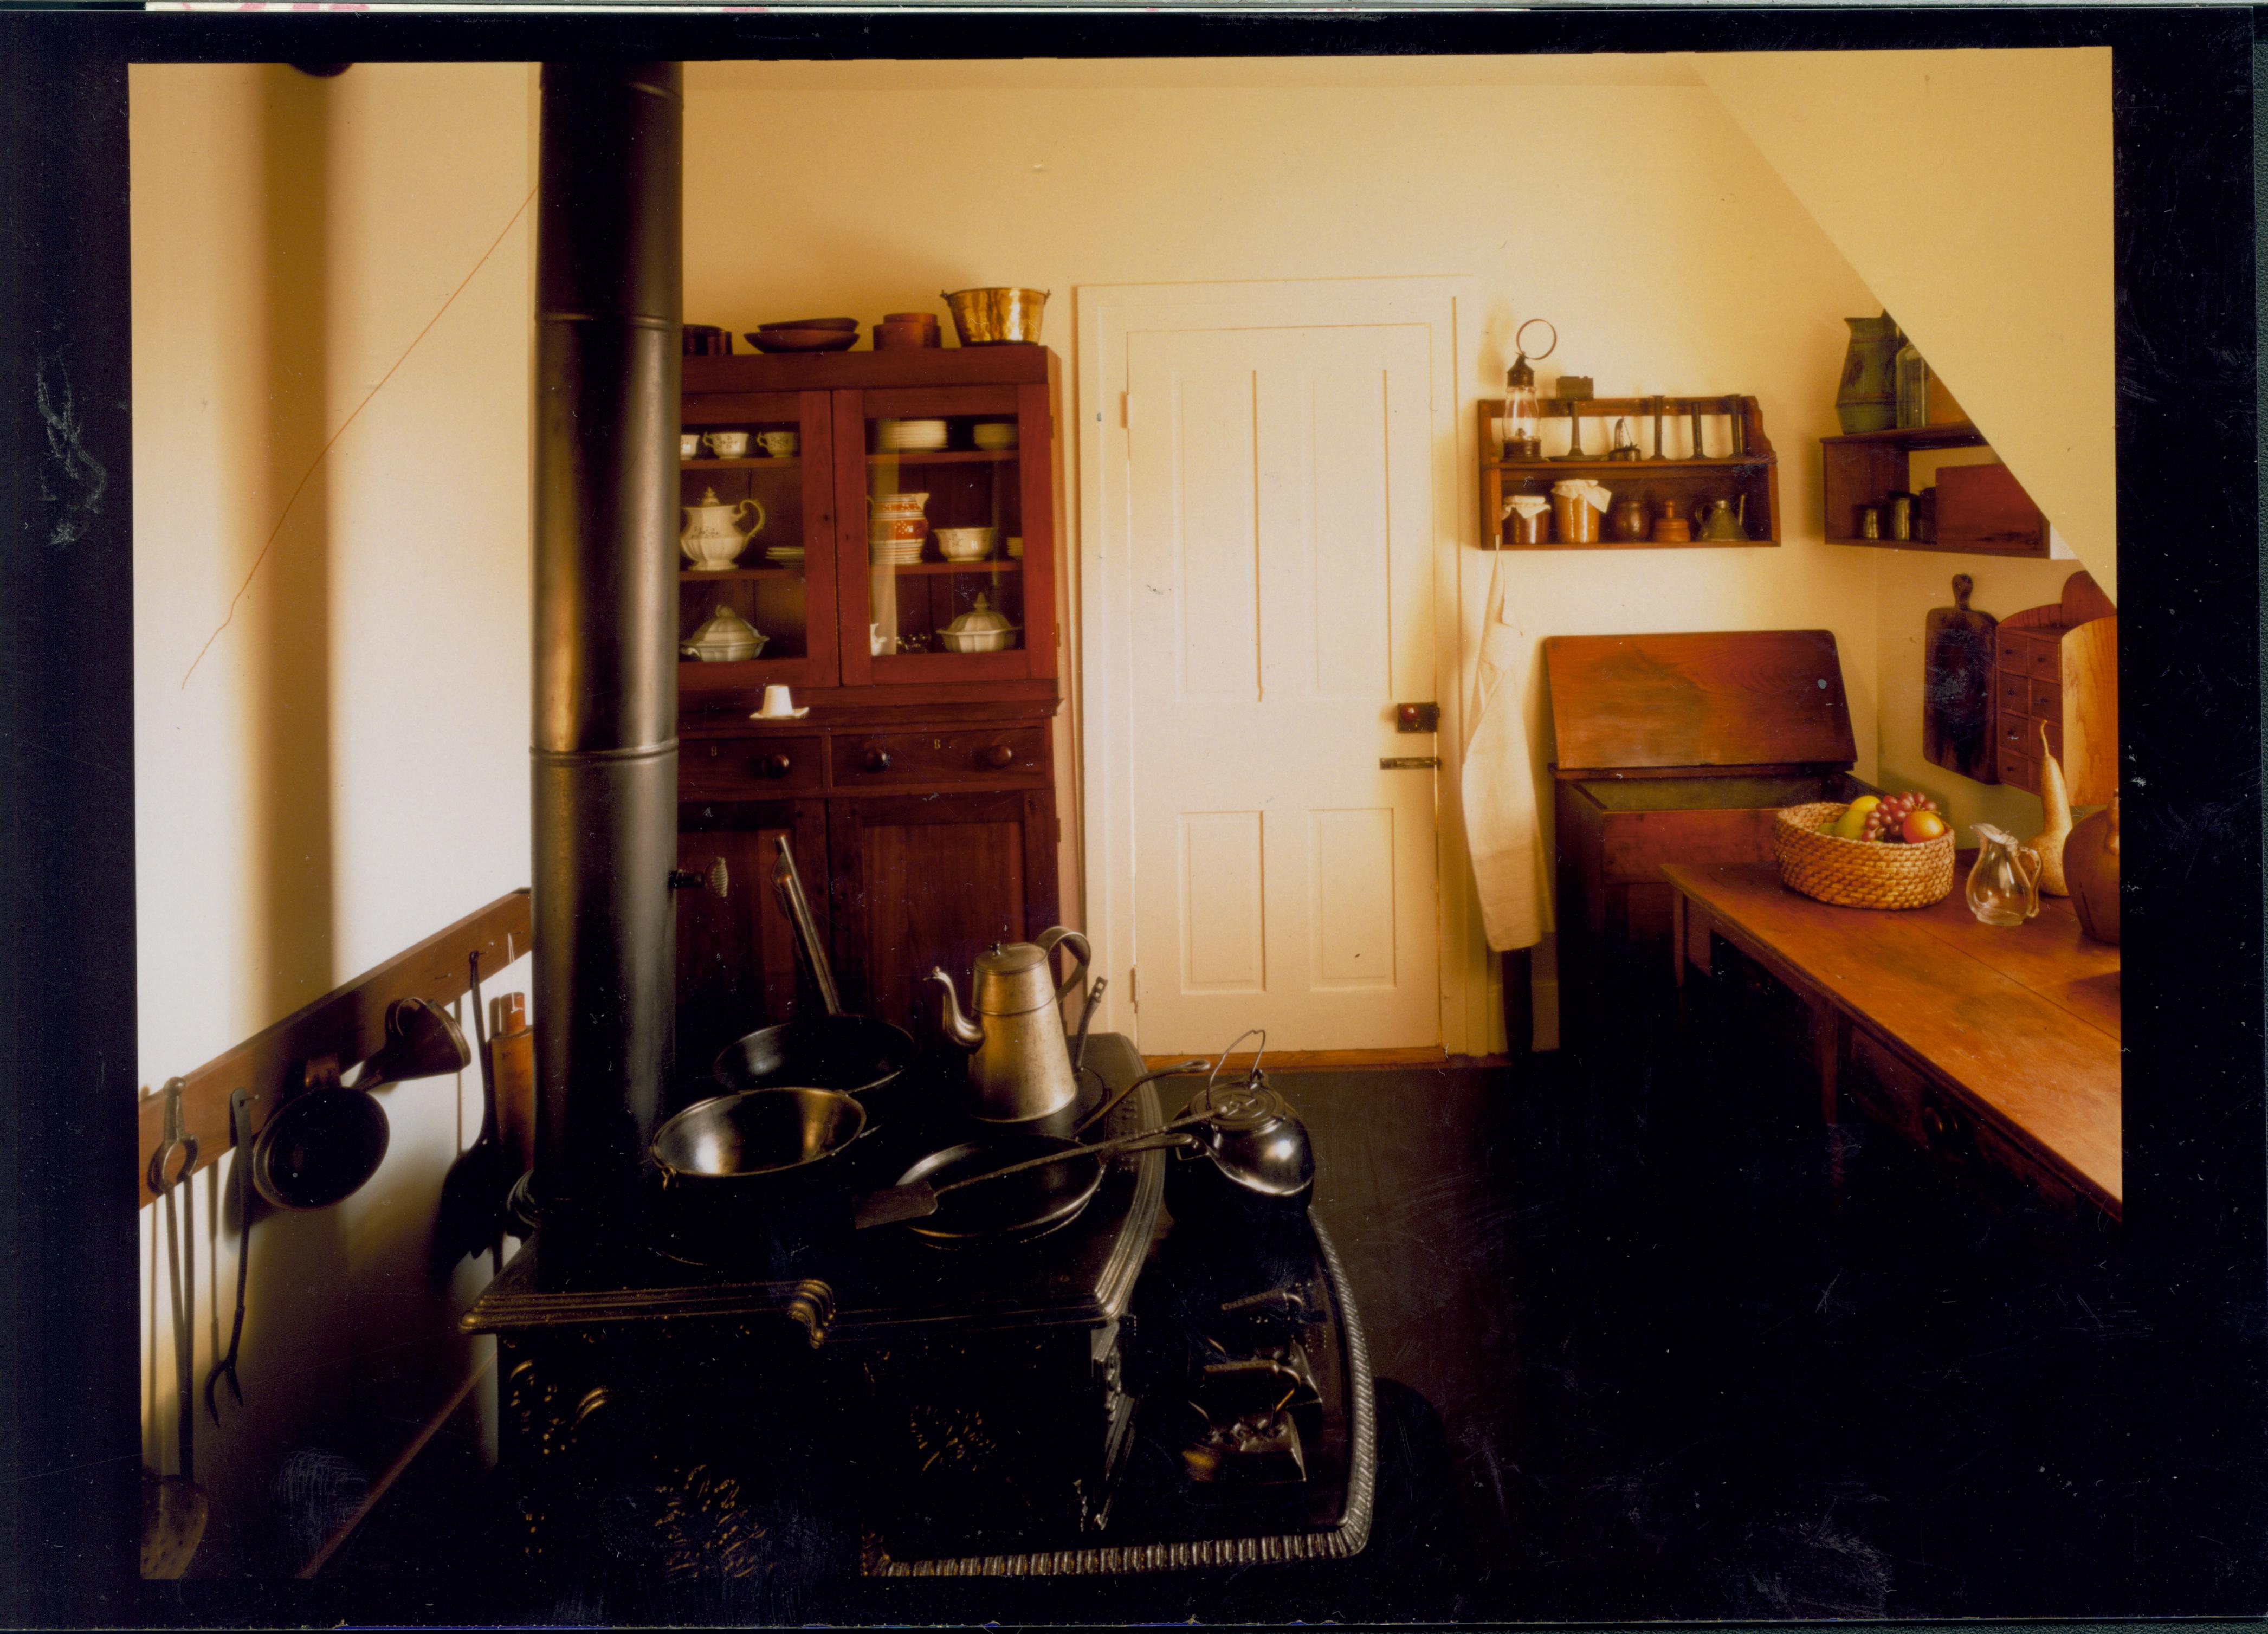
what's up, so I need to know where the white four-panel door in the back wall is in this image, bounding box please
[1127,325,1440,1055]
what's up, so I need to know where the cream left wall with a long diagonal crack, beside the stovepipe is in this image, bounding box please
[135,63,535,1568]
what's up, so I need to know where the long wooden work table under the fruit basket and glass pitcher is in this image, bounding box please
[1663,854,2123,1219]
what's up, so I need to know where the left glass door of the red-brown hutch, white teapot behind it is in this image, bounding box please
[678,392,837,694]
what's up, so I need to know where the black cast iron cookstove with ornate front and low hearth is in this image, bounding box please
[465,1035,1377,1588]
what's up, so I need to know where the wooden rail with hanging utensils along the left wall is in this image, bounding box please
[134,890,528,1207]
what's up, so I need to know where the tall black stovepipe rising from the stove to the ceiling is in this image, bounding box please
[531,63,685,1287]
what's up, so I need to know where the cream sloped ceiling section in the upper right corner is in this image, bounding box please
[1690,48,2118,599]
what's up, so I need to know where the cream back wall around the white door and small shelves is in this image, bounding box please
[685,57,1876,1046]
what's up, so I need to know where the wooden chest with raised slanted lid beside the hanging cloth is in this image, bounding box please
[1545,631,1873,1039]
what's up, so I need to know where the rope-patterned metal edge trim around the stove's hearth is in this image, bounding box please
[867,1212,1379,1577]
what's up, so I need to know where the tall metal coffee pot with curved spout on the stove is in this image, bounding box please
[930,926,1093,1123]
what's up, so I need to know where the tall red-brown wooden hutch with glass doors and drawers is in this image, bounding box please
[678,345,1062,1064]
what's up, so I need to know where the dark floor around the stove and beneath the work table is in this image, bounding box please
[195,994,2159,1623]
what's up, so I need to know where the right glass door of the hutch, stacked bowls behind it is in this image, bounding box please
[835,386,1055,686]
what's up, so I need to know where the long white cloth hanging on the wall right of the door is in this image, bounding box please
[1463,554,1552,951]
